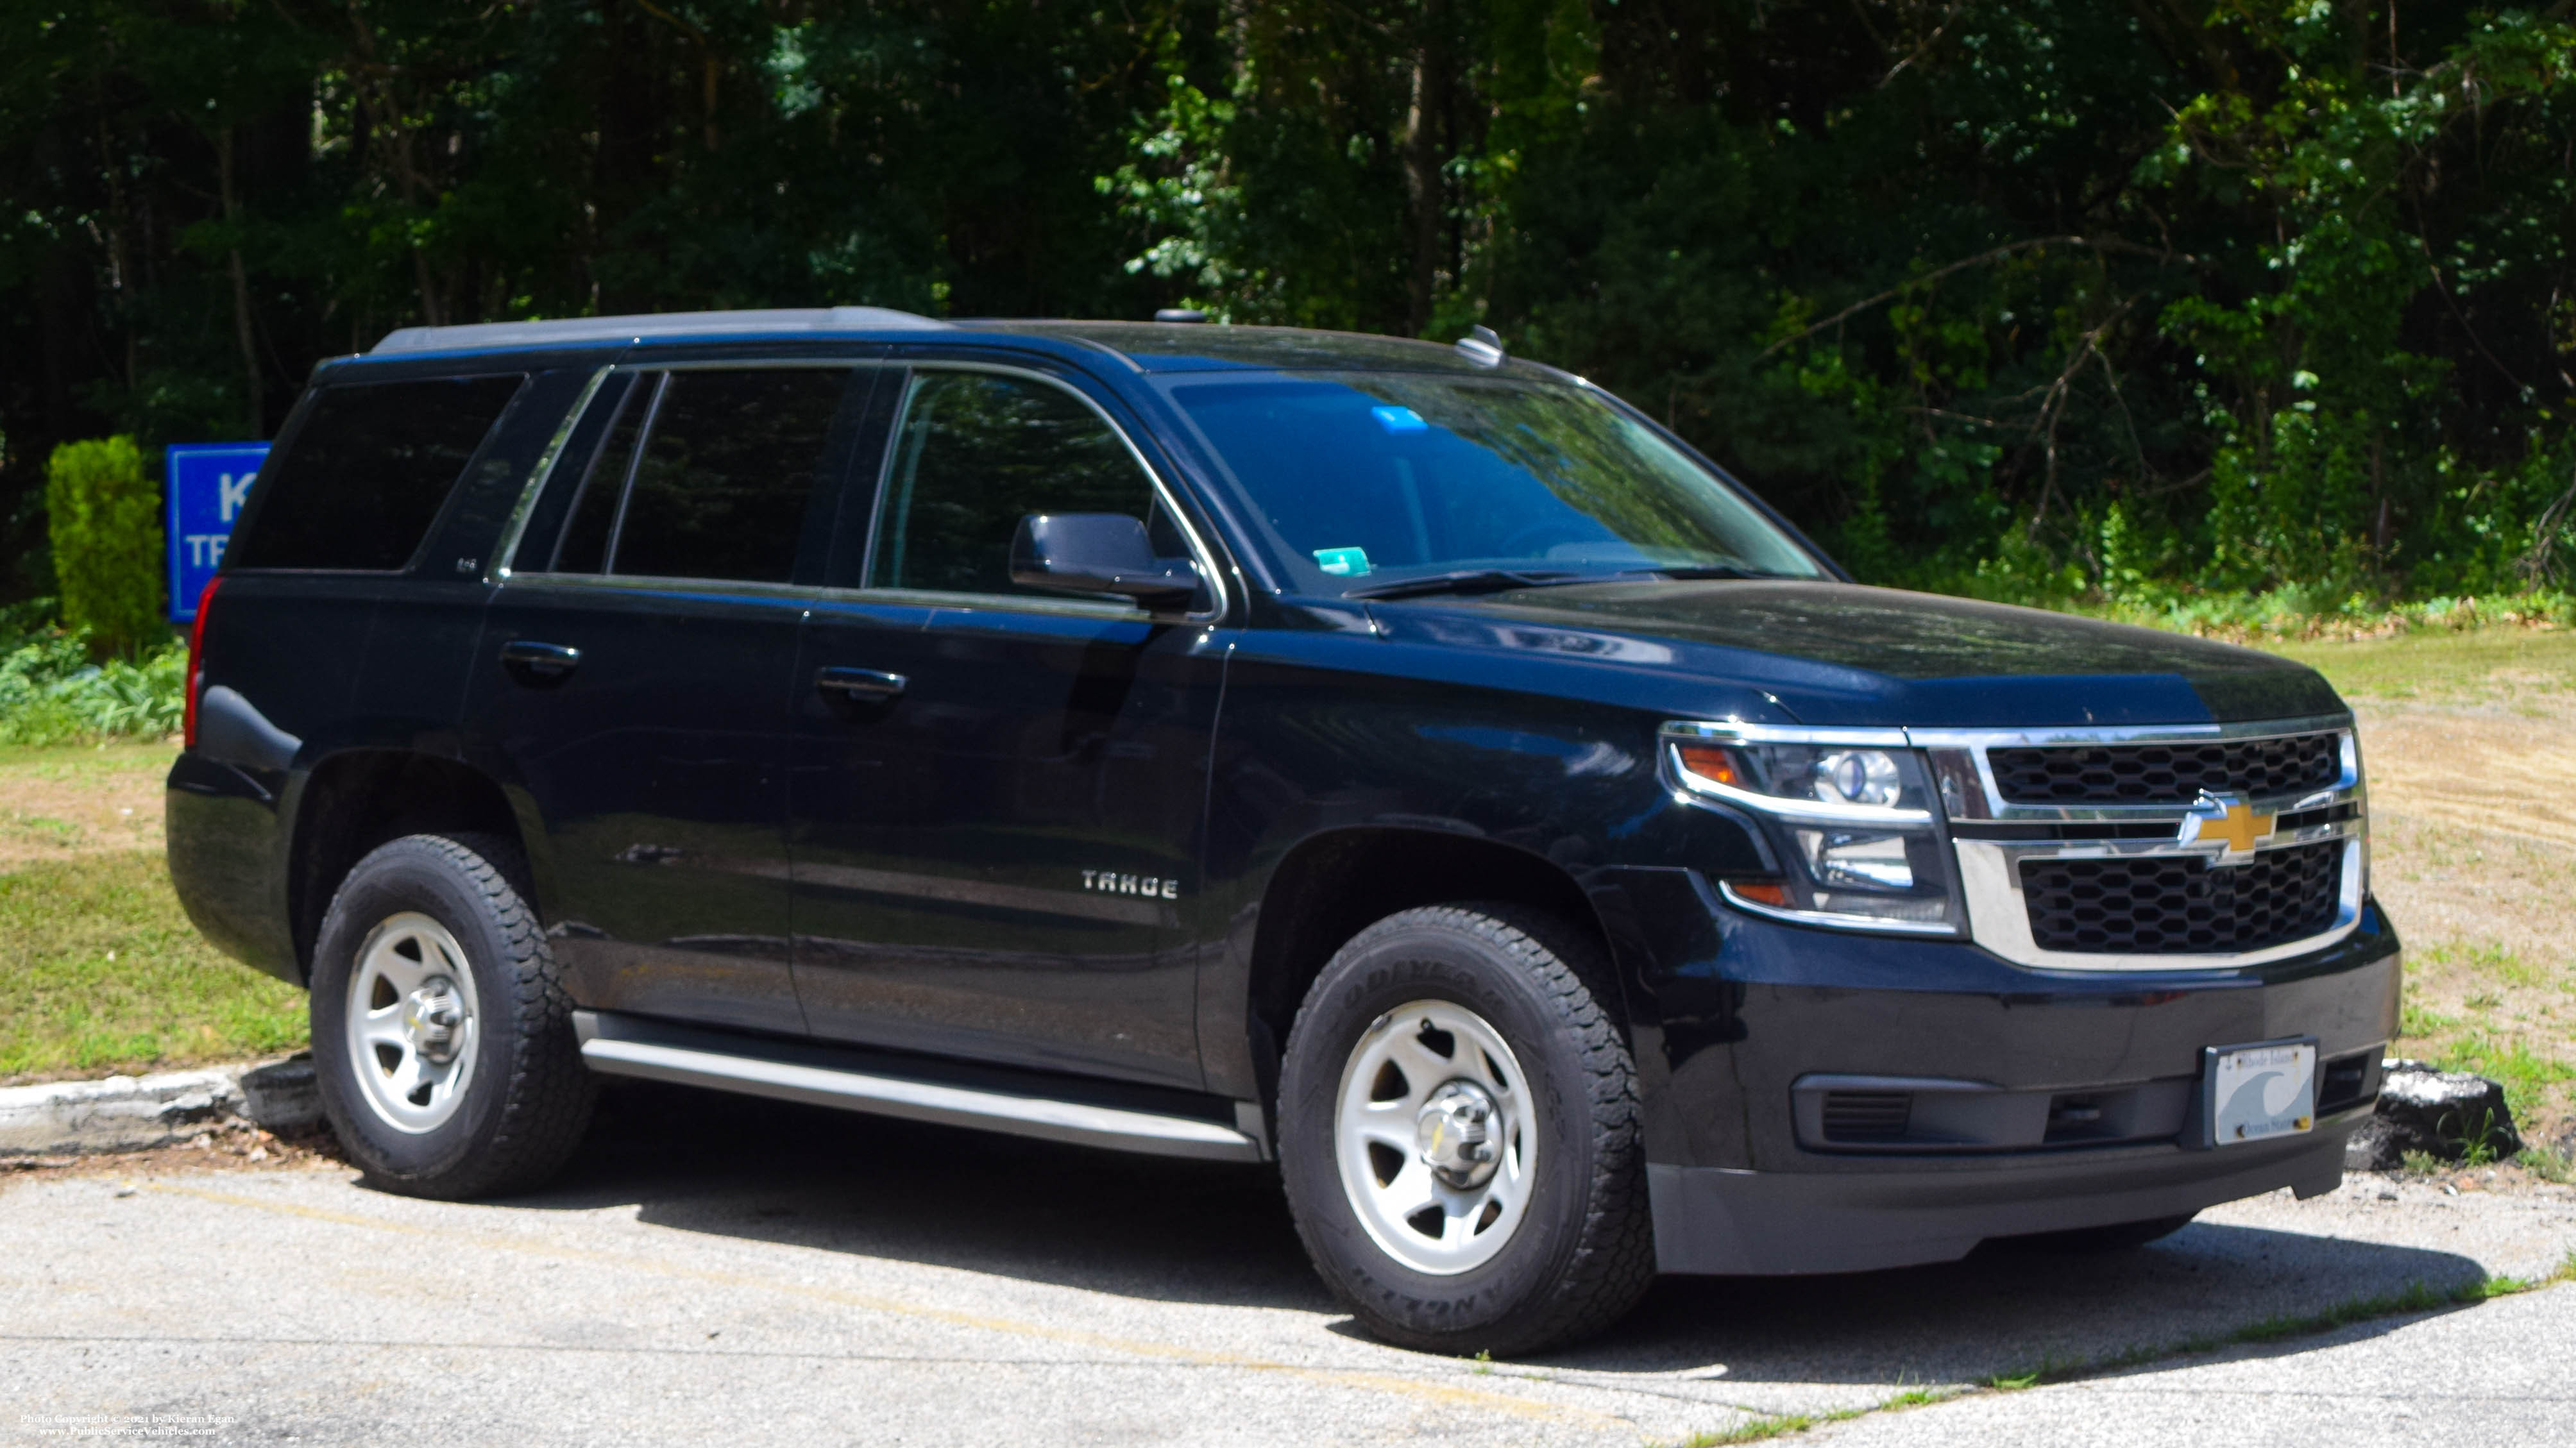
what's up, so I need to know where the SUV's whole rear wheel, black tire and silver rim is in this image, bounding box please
[312,835,595,1198]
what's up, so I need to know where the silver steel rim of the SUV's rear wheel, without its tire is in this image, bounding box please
[345,909,479,1134]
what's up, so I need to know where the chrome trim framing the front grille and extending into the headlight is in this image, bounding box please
[1661,714,2370,974]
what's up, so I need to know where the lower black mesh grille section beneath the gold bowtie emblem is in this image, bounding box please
[2022,840,2344,956]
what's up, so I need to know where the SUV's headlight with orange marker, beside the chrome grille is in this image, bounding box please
[1666,724,1965,935]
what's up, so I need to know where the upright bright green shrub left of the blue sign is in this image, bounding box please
[44,435,170,660]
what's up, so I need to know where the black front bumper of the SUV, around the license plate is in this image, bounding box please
[1595,871,2398,1273]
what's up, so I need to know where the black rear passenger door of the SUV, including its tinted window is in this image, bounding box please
[466,364,870,1033]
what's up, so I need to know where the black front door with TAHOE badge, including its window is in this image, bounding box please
[791,369,1224,1088]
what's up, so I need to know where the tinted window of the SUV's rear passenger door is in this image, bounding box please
[556,369,850,582]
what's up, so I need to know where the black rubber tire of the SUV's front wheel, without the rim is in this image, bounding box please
[1278,904,1654,1355]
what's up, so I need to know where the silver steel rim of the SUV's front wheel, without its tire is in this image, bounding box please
[1332,1000,1538,1278]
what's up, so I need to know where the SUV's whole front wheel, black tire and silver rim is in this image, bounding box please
[1280,904,1654,1352]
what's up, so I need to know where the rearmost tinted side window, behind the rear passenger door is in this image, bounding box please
[226,374,525,572]
